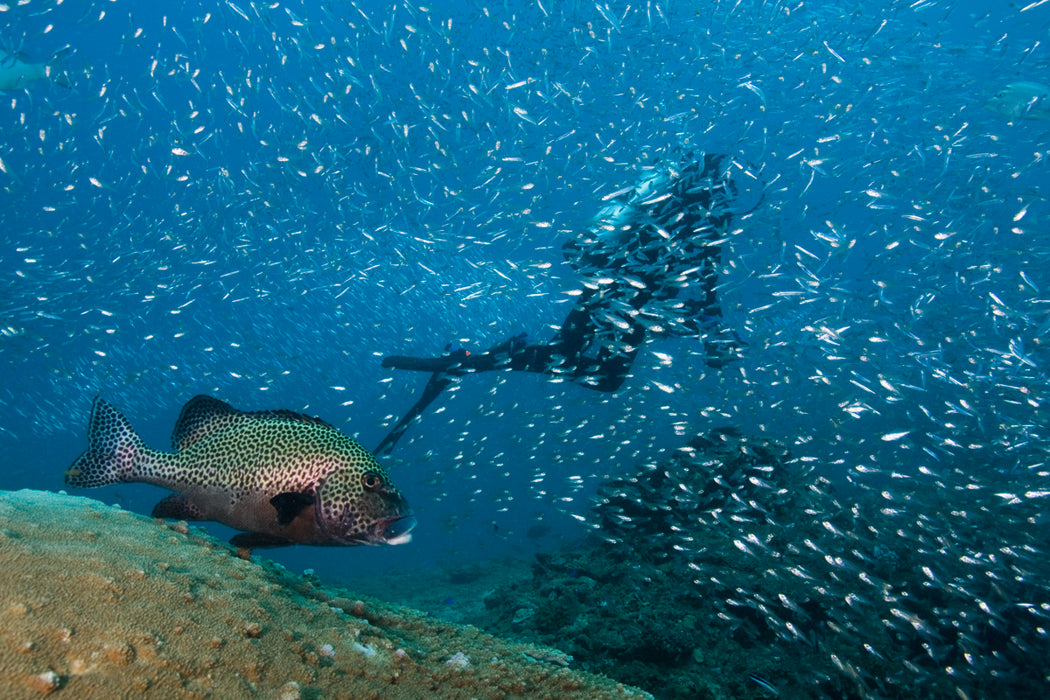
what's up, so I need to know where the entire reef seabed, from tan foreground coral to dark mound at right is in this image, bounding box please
[10,421,1050,700]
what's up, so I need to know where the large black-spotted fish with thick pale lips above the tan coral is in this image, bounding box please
[65,396,416,548]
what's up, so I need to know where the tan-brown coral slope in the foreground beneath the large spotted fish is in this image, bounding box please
[0,491,649,700]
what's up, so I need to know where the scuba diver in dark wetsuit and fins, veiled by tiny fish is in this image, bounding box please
[376,152,761,454]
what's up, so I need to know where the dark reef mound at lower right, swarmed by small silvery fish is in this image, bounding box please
[476,429,1050,700]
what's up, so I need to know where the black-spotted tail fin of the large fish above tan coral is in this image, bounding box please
[65,397,148,488]
